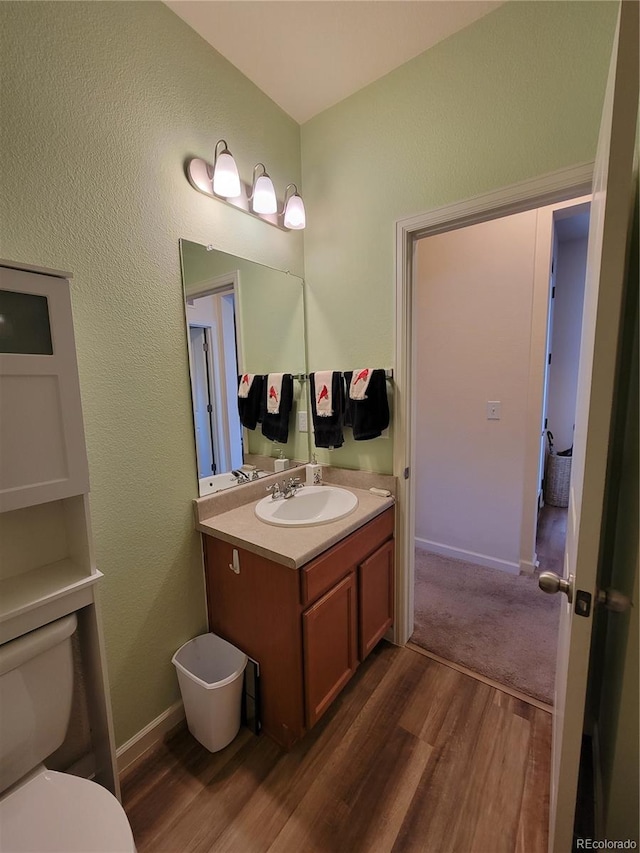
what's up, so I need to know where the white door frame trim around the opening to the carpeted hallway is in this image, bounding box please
[393,163,593,645]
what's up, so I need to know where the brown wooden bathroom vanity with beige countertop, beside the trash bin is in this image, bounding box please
[198,489,394,749]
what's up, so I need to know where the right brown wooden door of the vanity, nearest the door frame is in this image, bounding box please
[358,539,394,660]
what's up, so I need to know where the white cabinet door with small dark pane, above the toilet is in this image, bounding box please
[0,267,89,512]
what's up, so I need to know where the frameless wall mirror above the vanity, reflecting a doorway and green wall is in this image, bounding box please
[180,240,309,496]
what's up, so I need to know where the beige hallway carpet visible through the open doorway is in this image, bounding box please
[411,548,560,704]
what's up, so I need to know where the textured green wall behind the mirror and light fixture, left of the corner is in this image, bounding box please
[0,2,303,743]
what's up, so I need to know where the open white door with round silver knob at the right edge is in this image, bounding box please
[549,2,638,853]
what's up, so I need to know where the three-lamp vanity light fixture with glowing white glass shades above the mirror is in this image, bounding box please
[185,139,306,231]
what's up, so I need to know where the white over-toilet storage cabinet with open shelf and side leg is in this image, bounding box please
[0,261,120,797]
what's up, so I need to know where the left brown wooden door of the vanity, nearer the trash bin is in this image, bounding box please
[302,572,358,728]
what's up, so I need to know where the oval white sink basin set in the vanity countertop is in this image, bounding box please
[256,486,358,527]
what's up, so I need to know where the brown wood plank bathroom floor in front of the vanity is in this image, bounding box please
[123,642,551,853]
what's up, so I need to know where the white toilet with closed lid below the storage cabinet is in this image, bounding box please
[0,614,136,853]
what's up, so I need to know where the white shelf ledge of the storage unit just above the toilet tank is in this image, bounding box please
[0,559,102,643]
